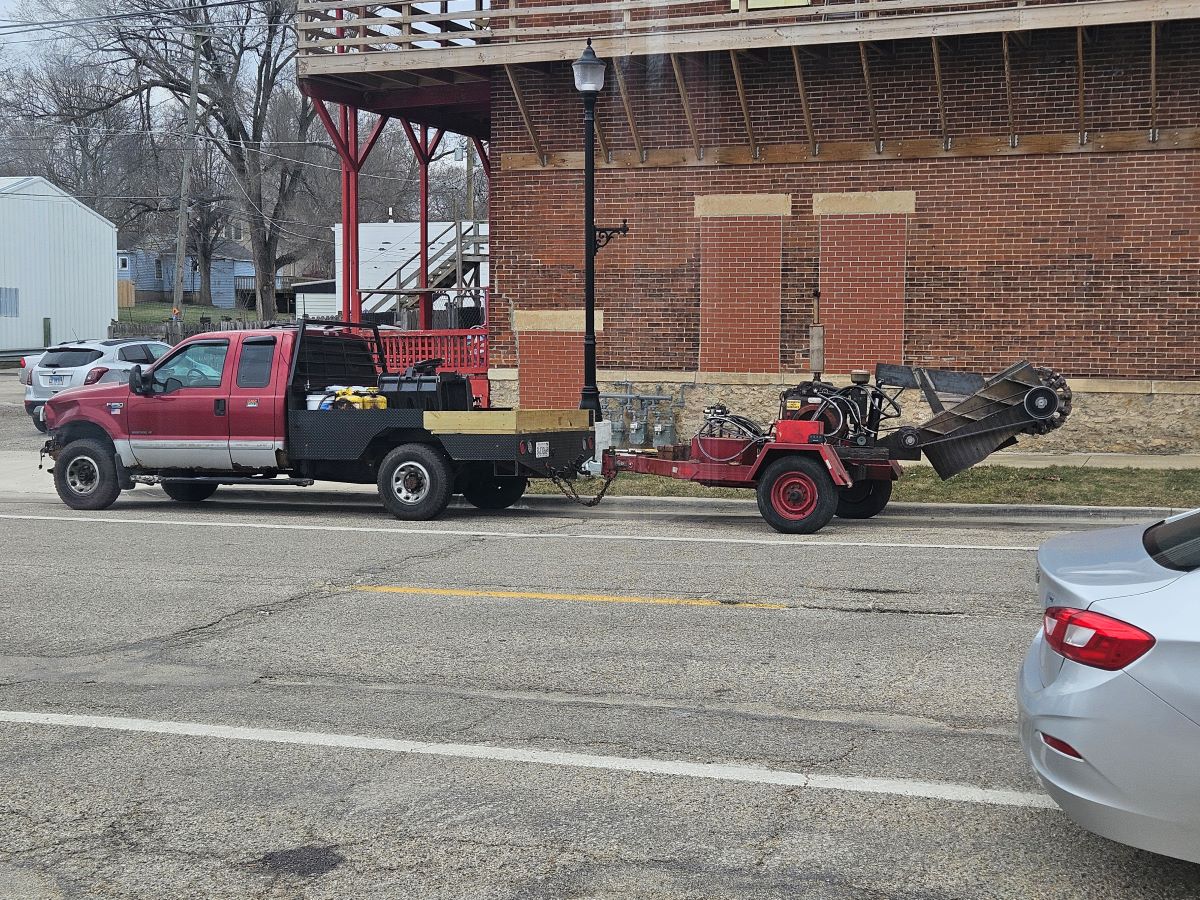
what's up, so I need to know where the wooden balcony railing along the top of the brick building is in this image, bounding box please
[296,0,1112,62]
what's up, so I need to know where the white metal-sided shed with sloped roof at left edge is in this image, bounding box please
[0,176,116,353]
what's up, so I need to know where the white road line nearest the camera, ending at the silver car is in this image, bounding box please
[0,710,1056,809]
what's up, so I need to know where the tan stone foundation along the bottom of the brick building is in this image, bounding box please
[492,370,1200,454]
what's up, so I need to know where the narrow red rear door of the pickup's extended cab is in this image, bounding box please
[229,335,287,469]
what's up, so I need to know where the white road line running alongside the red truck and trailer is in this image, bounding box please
[0,512,1038,553]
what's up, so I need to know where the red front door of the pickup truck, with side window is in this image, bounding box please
[128,338,233,472]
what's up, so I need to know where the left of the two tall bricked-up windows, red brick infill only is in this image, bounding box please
[700,216,782,372]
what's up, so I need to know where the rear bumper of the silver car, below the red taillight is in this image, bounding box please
[1018,634,1200,863]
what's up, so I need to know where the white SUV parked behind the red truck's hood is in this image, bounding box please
[20,337,170,432]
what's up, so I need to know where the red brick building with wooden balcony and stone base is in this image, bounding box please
[301,0,1200,450]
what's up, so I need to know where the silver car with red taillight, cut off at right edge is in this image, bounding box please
[1018,510,1200,863]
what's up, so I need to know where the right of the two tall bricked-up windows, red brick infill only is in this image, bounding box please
[821,215,907,374]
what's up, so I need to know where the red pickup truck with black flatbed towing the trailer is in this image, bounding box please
[42,322,595,520]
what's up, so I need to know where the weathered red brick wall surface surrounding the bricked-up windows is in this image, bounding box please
[491,22,1200,378]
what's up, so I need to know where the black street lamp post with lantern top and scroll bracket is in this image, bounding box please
[571,38,629,421]
